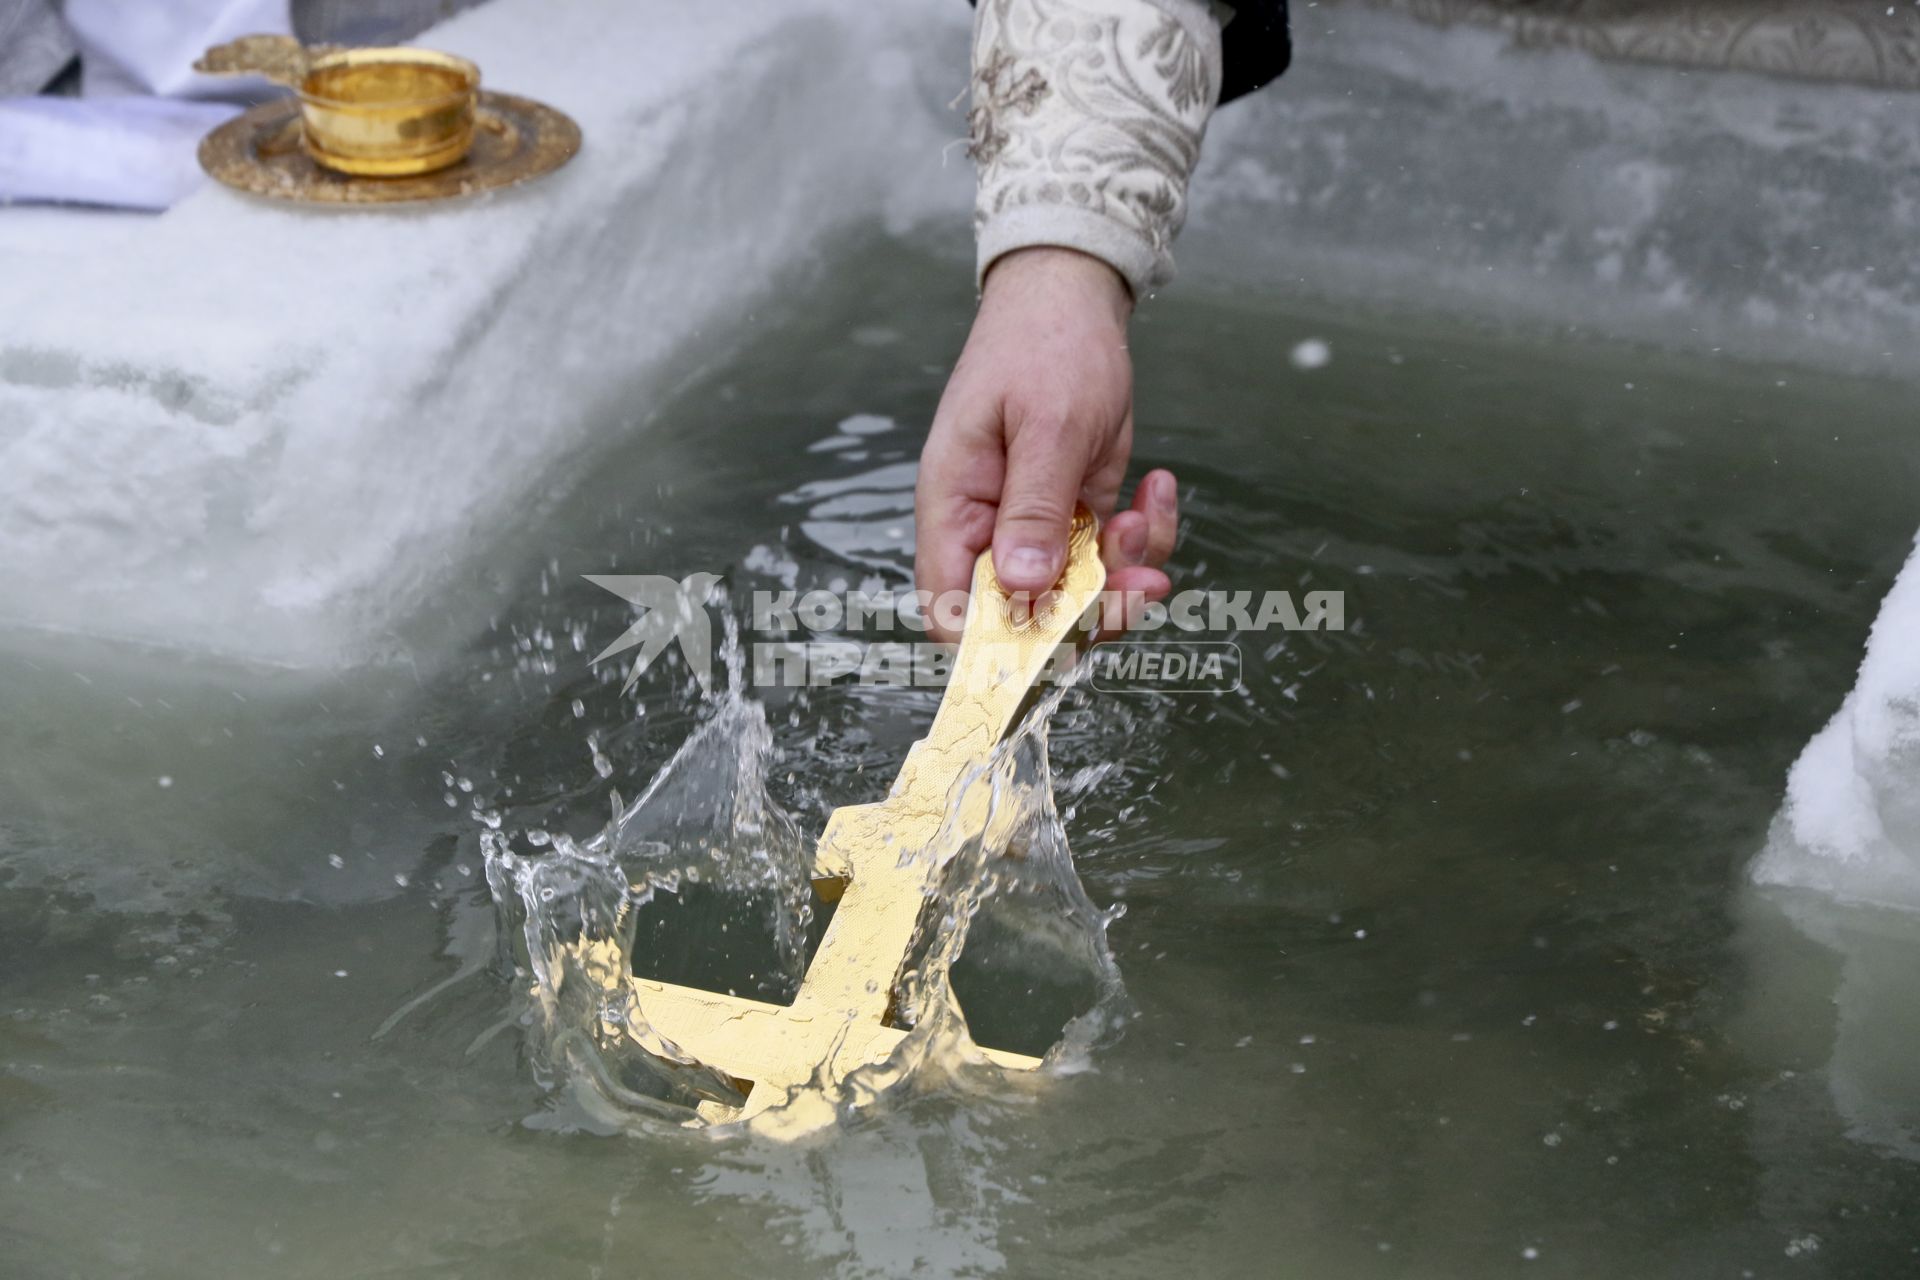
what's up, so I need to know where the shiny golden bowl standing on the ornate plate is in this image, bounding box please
[298,48,480,178]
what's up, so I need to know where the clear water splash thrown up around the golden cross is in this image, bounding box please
[482,637,1127,1132]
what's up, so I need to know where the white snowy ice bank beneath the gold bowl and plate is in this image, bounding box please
[0,0,970,666]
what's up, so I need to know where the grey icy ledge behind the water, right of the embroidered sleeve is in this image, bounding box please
[1181,4,1920,376]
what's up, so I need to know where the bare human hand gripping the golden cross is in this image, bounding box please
[914,248,1179,641]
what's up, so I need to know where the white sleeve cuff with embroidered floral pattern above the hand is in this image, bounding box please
[968,0,1221,296]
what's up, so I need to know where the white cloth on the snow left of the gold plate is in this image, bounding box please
[0,0,294,209]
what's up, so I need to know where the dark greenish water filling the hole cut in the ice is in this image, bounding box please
[0,237,1920,1280]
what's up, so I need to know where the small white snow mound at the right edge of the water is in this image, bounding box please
[1753,545,1920,910]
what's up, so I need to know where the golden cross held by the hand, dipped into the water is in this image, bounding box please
[599,507,1106,1128]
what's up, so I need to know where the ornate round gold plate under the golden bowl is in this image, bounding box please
[200,90,580,205]
